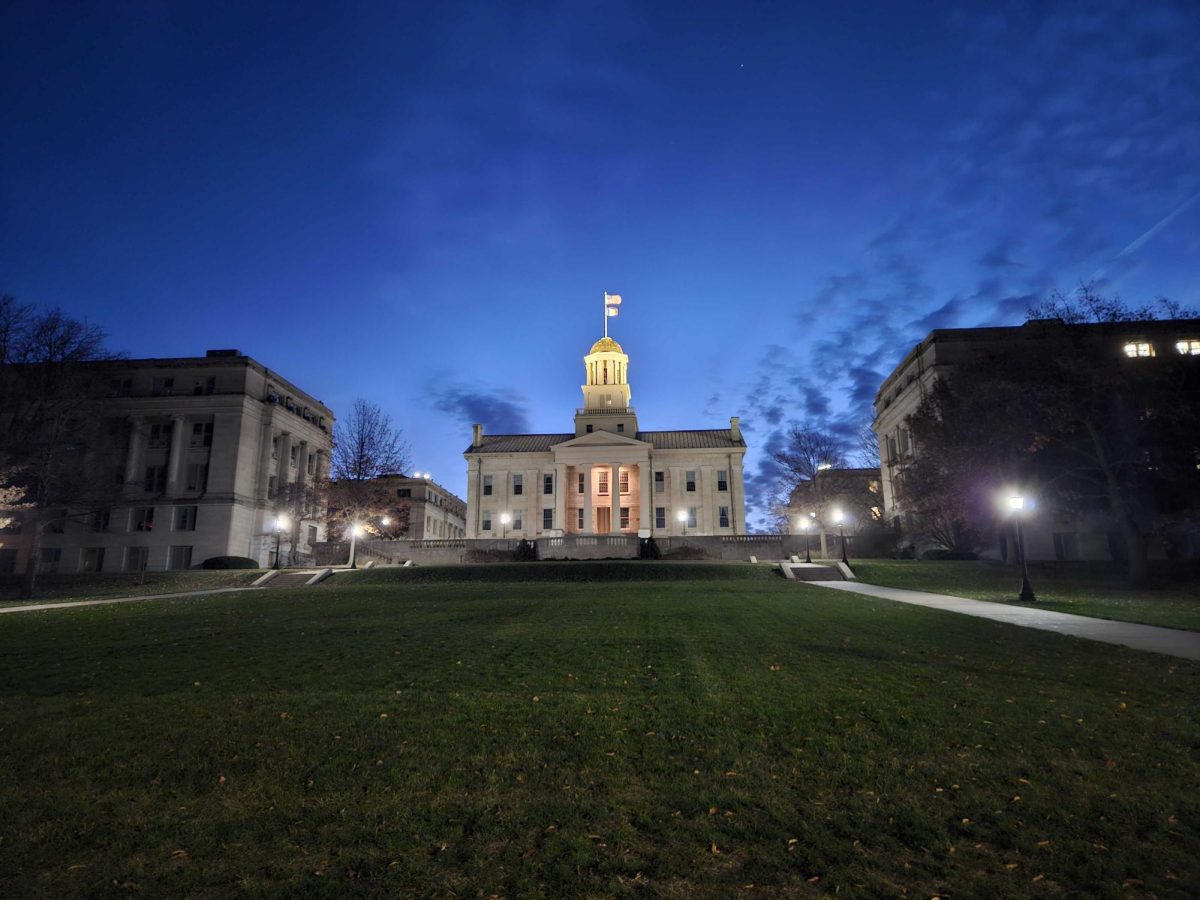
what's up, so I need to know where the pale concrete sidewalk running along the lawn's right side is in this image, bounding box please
[808,581,1200,660]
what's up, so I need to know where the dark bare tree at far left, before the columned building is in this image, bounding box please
[0,296,114,596]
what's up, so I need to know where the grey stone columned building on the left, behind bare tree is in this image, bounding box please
[0,350,334,572]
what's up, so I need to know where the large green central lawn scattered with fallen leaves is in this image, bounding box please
[0,563,1200,900]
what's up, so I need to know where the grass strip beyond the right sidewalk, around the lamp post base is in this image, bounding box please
[851,559,1200,631]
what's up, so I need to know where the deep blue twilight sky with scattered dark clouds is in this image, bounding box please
[0,0,1200,528]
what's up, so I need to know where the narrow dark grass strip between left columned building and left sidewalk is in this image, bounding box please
[0,569,263,605]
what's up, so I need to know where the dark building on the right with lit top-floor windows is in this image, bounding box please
[872,319,1200,559]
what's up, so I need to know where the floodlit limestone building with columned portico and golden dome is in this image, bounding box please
[463,336,746,539]
